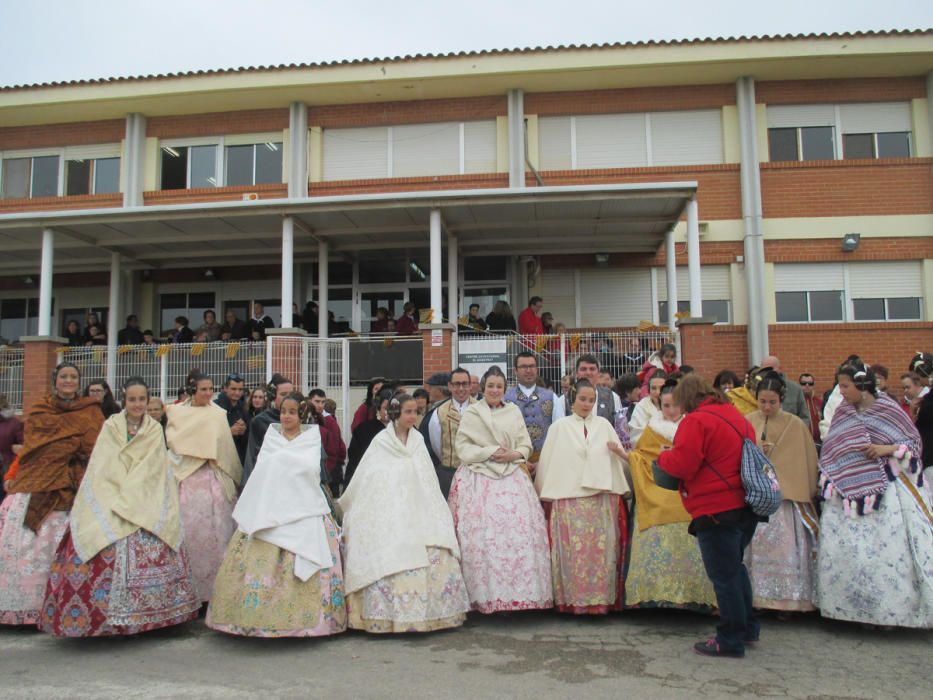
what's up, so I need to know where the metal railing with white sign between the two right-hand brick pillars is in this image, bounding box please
[458,329,679,386]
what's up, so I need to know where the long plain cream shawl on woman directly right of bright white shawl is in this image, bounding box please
[338,423,460,593]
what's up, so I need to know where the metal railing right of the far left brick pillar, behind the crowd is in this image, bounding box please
[60,342,267,401]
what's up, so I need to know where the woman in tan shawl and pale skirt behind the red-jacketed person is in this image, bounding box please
[745,372,819,612]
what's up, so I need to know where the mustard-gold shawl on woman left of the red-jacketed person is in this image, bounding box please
[628,421,691,530]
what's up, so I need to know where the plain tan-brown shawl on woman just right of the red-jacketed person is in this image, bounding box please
[746,411,820,503]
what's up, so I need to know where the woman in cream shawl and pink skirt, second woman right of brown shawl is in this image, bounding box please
[165,373,243,603]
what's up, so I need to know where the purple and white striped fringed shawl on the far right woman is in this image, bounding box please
[820,394,920,515]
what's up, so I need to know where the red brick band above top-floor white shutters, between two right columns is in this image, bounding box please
[525,83,735,117]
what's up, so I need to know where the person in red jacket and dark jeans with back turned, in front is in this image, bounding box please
[657,374,760,658]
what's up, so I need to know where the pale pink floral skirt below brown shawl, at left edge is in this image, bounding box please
[0,493,68,625]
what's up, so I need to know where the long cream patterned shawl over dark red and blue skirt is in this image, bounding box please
[71,411,181,561]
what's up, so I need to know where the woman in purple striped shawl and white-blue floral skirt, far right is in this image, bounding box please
[817,365,933,628]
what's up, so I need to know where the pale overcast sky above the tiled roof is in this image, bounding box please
[0,0,933,85]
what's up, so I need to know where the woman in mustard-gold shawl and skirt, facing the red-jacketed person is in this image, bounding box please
[625,380,716,612]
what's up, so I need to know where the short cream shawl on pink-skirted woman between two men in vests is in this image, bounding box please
[455,401,532,479]
